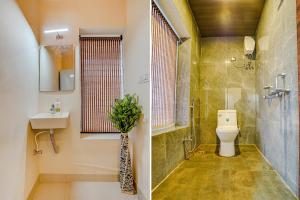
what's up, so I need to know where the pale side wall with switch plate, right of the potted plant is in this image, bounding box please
[124,0,151,200]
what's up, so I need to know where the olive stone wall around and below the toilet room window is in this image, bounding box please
[152,0,200,188]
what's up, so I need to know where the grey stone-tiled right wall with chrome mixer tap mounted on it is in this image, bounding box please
[256,0,299,194]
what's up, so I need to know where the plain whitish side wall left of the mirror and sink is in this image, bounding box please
[0,0,38,200]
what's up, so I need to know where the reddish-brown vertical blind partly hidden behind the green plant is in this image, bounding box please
[80,37,121,133]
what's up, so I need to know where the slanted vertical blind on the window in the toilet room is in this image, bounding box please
[151,3,178,128]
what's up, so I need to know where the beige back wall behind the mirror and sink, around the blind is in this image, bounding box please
[39,0,126,177]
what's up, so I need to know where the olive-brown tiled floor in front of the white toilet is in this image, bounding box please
[152,145,296,200]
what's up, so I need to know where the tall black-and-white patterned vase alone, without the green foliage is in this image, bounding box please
[120,133,136,194]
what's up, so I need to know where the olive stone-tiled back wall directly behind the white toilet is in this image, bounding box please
[198,37,256,144]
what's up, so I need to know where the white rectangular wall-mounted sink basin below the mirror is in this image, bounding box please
[30,112,69,129]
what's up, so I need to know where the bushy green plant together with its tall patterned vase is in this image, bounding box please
[108,94,142,194]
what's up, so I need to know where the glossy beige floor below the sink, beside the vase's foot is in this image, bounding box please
[30,182,137,200]
